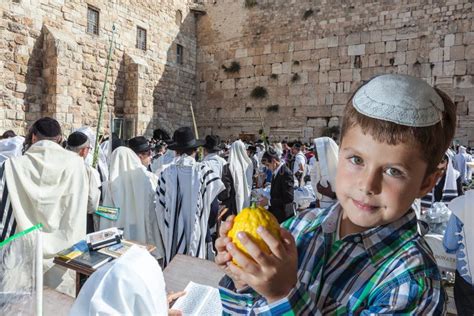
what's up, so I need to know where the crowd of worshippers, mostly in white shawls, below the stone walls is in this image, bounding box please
[0,117,472,296]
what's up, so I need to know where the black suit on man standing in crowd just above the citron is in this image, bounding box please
[269,165,294,223]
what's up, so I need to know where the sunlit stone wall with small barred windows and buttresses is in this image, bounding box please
[0,0,196,135]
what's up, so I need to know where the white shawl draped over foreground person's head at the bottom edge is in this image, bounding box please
[69,246,168,316]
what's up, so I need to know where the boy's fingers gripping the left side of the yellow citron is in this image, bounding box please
[214,215,246,289]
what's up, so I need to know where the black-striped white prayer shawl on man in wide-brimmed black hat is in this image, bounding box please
[156,157,224,266]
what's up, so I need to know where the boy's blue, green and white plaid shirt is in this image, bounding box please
[219,203,446,315]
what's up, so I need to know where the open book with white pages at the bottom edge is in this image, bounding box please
[171,282,222,316]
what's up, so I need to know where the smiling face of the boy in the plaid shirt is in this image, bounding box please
[336,126,436,233]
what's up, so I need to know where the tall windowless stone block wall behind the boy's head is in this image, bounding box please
[197,0,474,146]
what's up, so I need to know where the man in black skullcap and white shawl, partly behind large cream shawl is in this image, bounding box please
[66,132,102,233]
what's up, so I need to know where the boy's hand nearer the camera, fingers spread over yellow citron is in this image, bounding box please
[226,227,298,303]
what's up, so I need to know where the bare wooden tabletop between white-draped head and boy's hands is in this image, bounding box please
[163,255,224,293]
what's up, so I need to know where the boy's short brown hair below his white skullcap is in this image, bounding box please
[340,87,456,175]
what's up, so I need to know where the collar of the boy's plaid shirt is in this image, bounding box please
[321,202,417,266]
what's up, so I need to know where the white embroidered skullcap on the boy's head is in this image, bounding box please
[352,74,444,127]
